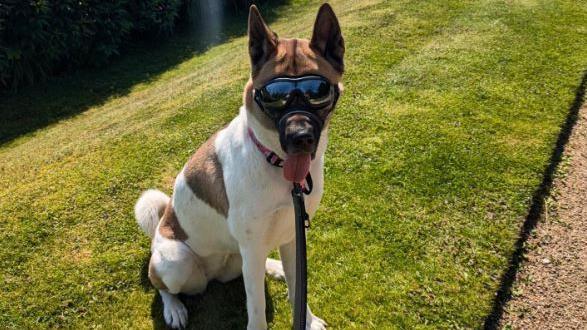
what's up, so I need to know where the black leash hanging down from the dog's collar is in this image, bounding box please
[291,173,312,330]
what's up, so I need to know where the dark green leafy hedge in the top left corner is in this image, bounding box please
[0,0,189,89]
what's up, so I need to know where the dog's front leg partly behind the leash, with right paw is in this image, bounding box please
[279,240,326,330]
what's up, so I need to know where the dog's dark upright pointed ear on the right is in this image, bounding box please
[310,3,344,73]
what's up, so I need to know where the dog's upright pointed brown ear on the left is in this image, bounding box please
[248,5,277,75]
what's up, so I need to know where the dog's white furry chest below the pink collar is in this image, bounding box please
[216,116,323,247]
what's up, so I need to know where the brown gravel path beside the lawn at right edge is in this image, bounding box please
[502,102,587,329]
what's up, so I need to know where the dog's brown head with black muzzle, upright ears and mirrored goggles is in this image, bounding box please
[244,4,345,168]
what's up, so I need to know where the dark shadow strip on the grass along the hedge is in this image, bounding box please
[0,0,289,146]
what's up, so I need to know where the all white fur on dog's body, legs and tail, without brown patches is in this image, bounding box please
[135,107,327,330]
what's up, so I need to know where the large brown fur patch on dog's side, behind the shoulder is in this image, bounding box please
[184,134,228,217]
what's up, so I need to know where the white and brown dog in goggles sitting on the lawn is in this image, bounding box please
[135,4,345,329]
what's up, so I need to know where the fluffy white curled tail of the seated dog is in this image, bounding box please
[135,189,169,238]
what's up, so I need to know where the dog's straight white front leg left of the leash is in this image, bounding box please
[241,244,268,330]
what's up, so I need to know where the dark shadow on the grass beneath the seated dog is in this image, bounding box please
[141,255,274,329]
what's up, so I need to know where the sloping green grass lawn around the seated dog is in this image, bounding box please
[0,0,587,329]
